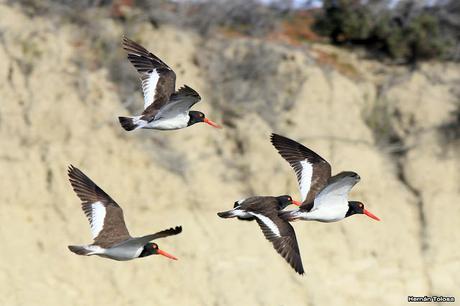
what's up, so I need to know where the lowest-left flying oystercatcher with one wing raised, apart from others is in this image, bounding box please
[68,166,182,261]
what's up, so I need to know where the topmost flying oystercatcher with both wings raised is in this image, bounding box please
[118,37,220,131]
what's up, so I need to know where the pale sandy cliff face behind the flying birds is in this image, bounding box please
[0,5,460,306]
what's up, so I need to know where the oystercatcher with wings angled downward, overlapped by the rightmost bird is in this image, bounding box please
[217,195,304,274]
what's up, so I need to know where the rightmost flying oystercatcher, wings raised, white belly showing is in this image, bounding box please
[271,134,380,222]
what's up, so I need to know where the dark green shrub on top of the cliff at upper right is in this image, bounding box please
[314,0,451,62]
